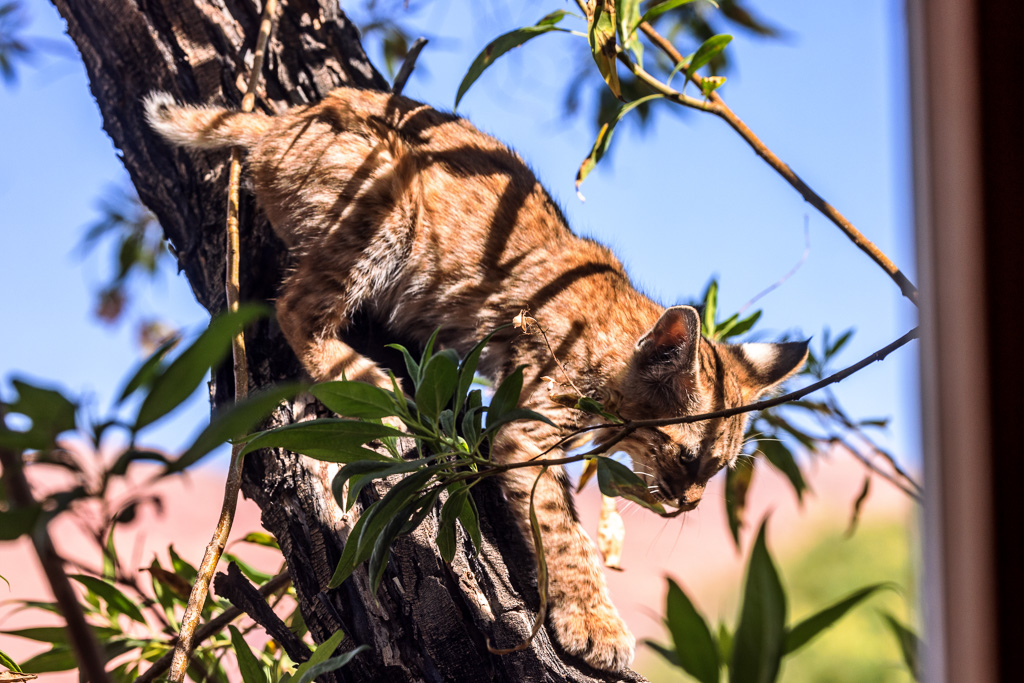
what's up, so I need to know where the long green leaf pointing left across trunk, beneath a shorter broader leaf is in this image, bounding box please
[242,418,404,463]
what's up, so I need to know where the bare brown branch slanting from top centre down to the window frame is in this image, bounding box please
[630,19,918,305]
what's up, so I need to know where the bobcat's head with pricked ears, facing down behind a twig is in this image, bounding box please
[609,306,807,510]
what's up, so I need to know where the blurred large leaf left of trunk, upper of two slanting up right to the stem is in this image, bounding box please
[135,304,268,431]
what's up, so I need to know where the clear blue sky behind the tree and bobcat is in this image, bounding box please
[0,0,921,471]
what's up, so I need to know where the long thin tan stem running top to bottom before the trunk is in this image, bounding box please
[169,0,278,683]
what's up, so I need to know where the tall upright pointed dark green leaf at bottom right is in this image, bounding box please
[729,519,785,683]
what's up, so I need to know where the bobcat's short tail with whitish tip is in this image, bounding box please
[143,92,273,150]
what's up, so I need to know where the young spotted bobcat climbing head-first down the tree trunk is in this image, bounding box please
[145,88,807,671]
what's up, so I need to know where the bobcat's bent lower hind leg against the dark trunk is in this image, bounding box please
[276,257,392,389]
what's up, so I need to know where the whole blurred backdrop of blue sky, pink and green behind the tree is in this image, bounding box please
[0,0,922,681]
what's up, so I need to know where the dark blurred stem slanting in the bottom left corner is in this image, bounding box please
[0,417,110,683]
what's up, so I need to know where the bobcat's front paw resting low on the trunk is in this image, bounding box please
[551,603,637,671]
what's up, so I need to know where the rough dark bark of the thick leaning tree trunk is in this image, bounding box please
[52,0,642,683]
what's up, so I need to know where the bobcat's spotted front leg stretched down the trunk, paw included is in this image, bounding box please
[495,422,636,671]
